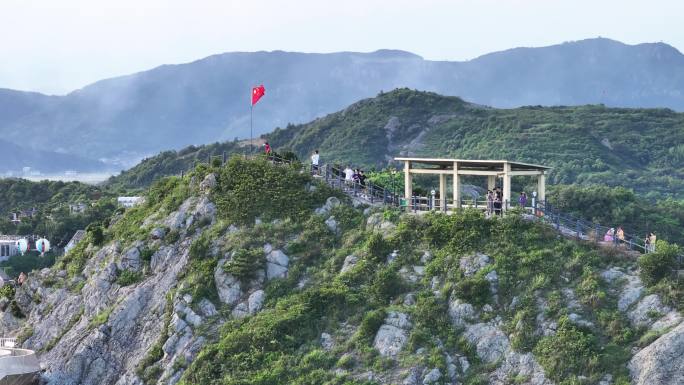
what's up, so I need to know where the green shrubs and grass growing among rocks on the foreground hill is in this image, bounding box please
[42,159,682,385]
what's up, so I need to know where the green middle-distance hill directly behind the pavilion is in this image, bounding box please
[115,89,684,199]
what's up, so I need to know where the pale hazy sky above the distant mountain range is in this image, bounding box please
[0,0,684,94]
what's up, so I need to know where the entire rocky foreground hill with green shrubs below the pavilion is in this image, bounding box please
[0,158,684,385]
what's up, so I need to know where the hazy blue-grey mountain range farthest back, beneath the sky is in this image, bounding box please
[0,38,684,171]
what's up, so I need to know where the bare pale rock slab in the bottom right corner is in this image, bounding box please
[629,324,684,385]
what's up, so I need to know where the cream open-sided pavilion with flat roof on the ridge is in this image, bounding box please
[394,157,551,211]
